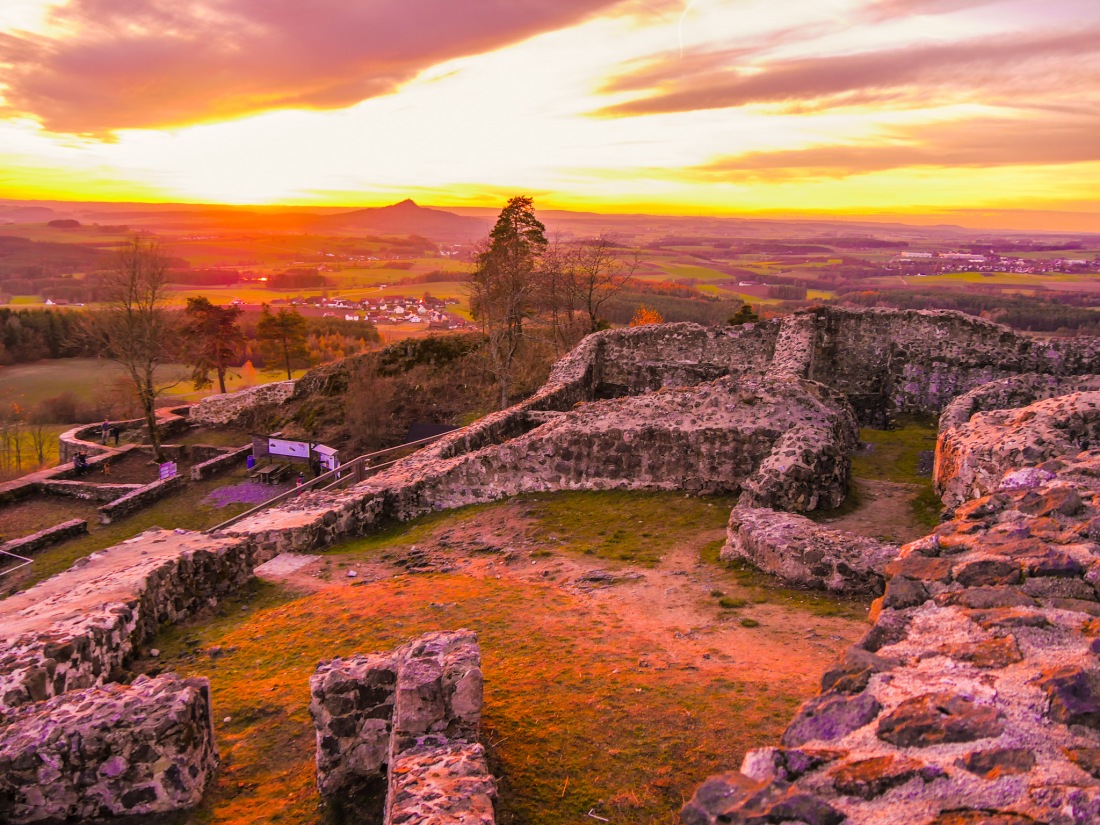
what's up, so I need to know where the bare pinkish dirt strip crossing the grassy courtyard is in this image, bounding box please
[256,501,866,690]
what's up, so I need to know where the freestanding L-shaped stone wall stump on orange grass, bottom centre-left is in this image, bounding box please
[309,630,496,825]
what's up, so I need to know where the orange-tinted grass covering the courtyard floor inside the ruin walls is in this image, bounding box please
[144,493,865,825]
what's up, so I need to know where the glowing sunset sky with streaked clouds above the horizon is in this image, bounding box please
[0,0,1100,231]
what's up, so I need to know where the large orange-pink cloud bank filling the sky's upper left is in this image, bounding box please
[0,0,633,135]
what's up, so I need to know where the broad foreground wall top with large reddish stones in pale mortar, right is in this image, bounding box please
[683,394,1100,825]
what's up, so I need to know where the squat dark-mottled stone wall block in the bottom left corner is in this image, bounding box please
[0,674,218,825]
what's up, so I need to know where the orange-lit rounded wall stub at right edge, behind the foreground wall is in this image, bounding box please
[934,392,1100,508]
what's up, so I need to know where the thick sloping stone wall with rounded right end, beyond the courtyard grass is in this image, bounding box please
[228,376,857,552]
